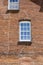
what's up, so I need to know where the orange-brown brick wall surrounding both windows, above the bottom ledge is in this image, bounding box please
[0,0,43,64]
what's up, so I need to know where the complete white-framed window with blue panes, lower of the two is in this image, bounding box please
[19,21,31,42]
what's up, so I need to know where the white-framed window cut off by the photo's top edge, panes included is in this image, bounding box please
[8,0,19,10]
